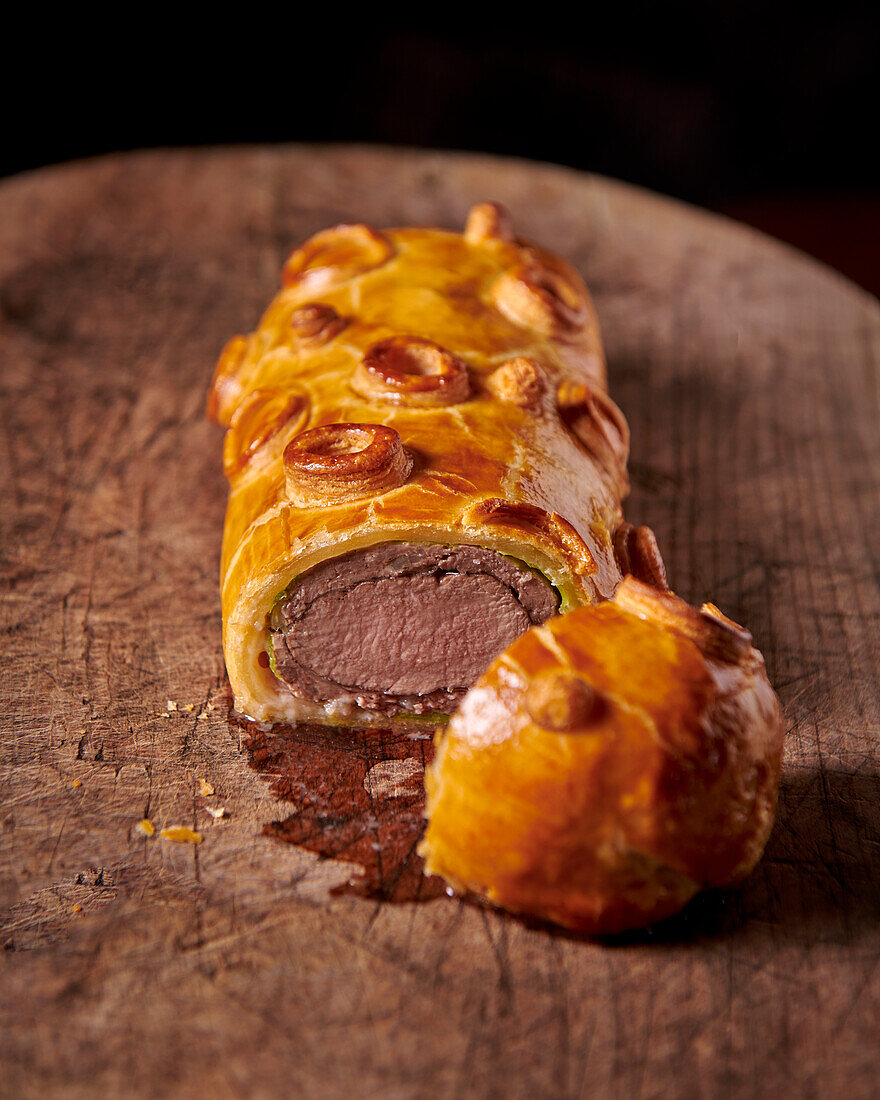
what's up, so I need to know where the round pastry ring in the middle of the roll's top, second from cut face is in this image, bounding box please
[352,336,471,408]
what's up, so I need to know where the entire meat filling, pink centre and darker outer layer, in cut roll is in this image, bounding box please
[272,542,558,716]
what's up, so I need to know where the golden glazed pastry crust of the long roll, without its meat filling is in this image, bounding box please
[208,204,628,724]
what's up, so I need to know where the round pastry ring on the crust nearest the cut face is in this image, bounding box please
[284,424,413,507]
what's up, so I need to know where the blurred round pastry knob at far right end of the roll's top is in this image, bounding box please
[492,256,590,339]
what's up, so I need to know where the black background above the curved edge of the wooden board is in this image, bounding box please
[0,0,880,292]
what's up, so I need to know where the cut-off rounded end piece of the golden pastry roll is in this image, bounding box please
[420,578,783,934]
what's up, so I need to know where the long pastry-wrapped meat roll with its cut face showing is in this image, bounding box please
[209,204,646,725]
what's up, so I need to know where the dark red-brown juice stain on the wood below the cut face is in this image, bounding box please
[240,725,446,902]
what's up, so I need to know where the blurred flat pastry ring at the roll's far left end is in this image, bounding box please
[282,223,394,290]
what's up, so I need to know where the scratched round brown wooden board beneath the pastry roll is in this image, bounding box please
[0,147,880,1100]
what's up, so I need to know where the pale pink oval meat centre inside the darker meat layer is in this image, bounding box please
[287,573,531,695]
